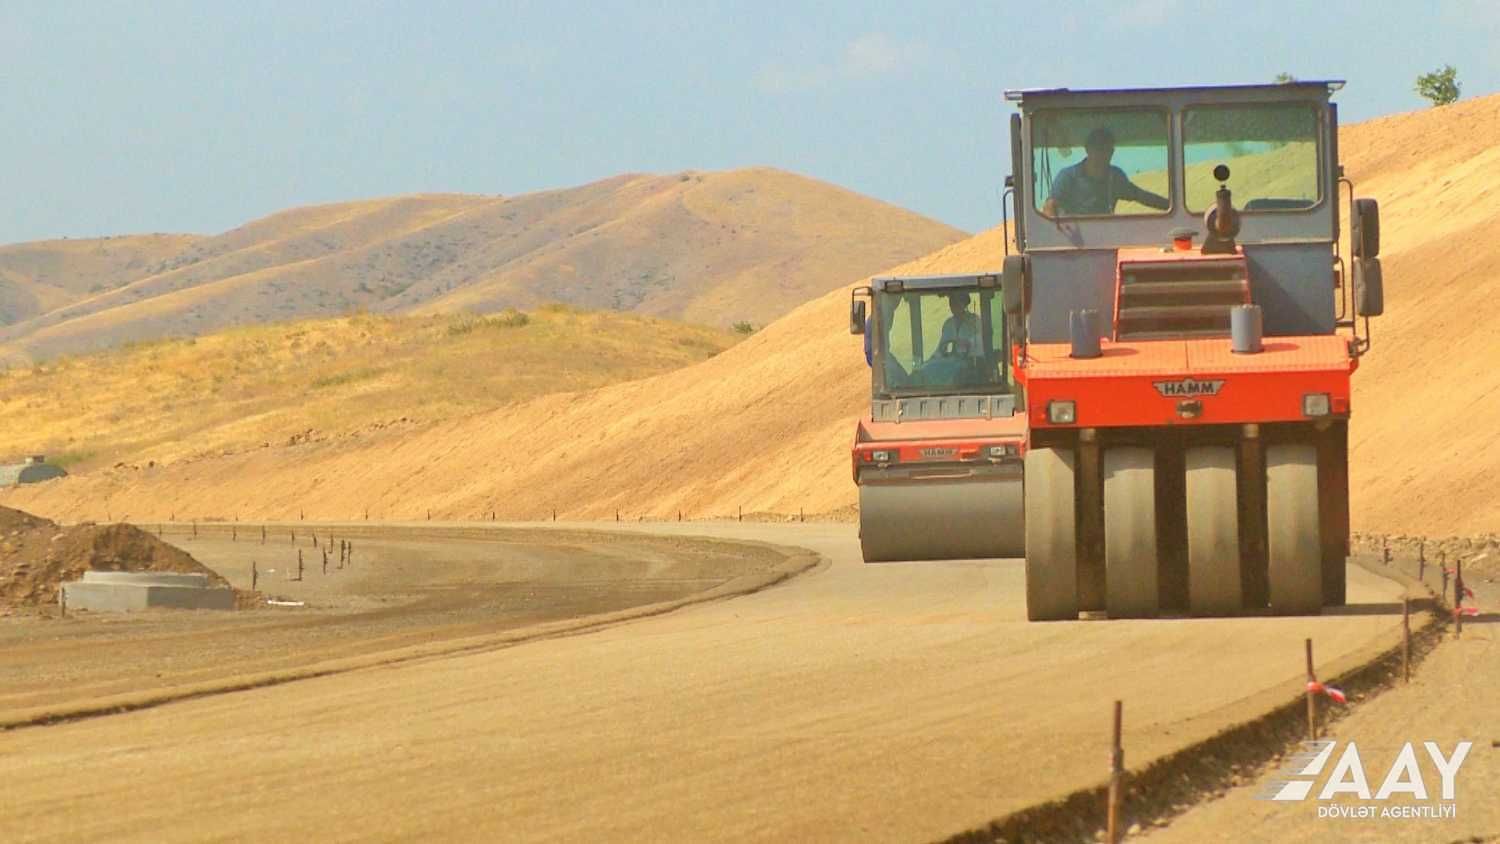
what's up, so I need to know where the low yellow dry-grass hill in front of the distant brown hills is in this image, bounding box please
[0,306,735,471]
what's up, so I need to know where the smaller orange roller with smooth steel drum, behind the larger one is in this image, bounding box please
[849,274,1026,562]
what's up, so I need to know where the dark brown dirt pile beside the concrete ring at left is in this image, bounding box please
[0,507,230,609]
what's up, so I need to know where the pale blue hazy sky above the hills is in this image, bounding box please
[0,0,1500,243]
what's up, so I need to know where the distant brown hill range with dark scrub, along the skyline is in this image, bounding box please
[0,168,963,361]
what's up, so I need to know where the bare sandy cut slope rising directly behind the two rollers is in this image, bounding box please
[3,96,1500,534]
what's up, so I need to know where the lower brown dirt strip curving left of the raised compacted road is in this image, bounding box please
[0,525,785,729]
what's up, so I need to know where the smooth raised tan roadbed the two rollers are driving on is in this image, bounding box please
[0,523,1401,841]
